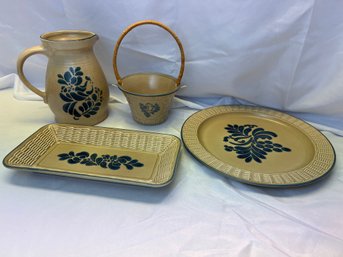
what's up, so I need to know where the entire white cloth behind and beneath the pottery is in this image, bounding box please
[0,0,343,257]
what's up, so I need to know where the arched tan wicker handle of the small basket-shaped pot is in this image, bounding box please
[113,20,185,85]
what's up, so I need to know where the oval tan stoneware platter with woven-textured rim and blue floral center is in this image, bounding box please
[181,105,335,187]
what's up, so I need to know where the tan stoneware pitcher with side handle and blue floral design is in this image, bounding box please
[17,30,109,125]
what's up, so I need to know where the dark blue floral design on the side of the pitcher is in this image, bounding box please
[57,67,103,120]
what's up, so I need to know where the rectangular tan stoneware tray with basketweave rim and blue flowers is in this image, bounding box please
[3,124,181,187]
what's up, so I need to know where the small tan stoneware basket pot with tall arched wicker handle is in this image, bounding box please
[113,20,185,125]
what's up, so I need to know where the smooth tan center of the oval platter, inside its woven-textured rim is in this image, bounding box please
[198,112,314,174]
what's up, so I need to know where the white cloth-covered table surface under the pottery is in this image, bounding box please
[0,89,343,257]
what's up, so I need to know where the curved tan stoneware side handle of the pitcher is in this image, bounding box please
[17,46,47,103]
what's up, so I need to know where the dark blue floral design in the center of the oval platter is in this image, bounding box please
[224,124,291,163]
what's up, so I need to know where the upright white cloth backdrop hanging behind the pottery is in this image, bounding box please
[0,0,343,122]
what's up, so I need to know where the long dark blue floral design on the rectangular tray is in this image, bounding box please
[58,151,144,170]
